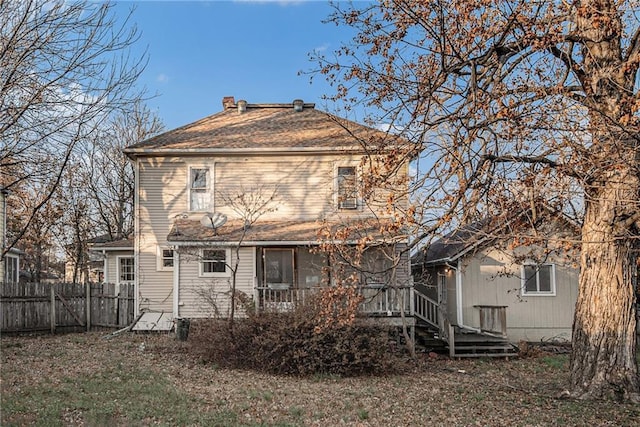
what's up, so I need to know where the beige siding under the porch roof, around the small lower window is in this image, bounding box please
[178,247,256,318]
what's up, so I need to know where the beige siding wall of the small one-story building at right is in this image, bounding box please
[462,250,578,341]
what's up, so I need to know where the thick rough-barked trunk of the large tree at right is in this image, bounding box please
[571,167,640,402]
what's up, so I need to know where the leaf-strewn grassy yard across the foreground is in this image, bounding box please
[0,332,640,426]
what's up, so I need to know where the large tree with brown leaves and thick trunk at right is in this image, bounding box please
[315,0,640,401]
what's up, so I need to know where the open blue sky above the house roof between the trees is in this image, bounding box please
[116,1,355,129]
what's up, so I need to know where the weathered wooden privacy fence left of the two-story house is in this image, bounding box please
[0,283,135,333]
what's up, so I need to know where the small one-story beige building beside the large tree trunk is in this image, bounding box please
[412,208,580,350]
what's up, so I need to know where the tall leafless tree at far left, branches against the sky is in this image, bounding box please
[0,0,145,257]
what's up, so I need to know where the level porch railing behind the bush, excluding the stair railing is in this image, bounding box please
[256,286,412,316]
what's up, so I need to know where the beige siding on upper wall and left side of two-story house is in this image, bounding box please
[136,153,408,312]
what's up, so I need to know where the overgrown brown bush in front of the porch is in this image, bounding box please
[189,292,400,376]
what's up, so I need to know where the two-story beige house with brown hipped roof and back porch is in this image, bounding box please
[121,97,411,329]
